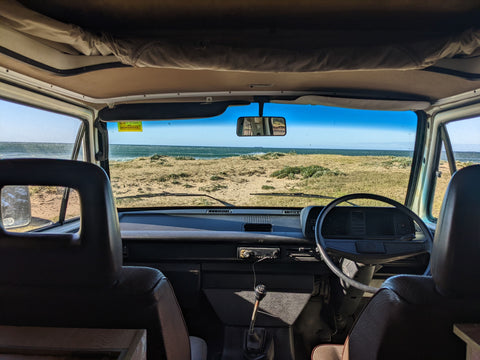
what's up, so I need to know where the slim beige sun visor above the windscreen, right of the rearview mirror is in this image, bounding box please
[272,95,431,111]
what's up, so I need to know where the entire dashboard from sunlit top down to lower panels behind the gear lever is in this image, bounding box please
[47,202,424,326]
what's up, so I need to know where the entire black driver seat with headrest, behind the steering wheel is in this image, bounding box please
[312,165,480,360]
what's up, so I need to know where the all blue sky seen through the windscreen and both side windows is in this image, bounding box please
[0,100,480,151]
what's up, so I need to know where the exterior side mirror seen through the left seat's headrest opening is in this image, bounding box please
[1,185,32,229]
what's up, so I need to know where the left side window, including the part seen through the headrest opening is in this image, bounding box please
[0,100,84,232]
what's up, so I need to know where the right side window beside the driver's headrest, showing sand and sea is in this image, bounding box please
[431,117,480,218]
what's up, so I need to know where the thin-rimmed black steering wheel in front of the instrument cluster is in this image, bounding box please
[315,194,433,293]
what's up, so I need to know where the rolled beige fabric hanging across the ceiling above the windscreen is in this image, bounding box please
[0,0,480,72]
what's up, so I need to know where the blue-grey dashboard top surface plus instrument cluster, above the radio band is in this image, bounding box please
[119,206,415,242]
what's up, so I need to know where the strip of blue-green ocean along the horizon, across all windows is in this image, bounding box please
[0,142,480,163]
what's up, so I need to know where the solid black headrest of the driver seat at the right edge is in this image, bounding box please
[431,165,480,297]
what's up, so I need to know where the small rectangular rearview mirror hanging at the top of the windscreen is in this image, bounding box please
[237,116,287,136]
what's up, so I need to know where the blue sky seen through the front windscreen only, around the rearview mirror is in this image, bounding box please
[108,104,417,150]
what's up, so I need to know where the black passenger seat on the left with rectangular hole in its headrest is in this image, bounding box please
[0,159,204,360]
